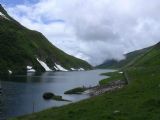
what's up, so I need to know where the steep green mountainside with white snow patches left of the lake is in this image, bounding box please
[0,5,92,74]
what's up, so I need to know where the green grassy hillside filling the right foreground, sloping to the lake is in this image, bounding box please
[11,41,160,120]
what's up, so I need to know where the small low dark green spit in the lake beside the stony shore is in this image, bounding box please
[64,87,87,94]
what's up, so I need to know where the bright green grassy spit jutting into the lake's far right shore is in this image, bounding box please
[99,72,125,85]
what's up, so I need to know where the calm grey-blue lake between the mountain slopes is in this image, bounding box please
[2,70,113,117]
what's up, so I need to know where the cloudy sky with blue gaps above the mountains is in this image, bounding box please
[2,0,160,65]
